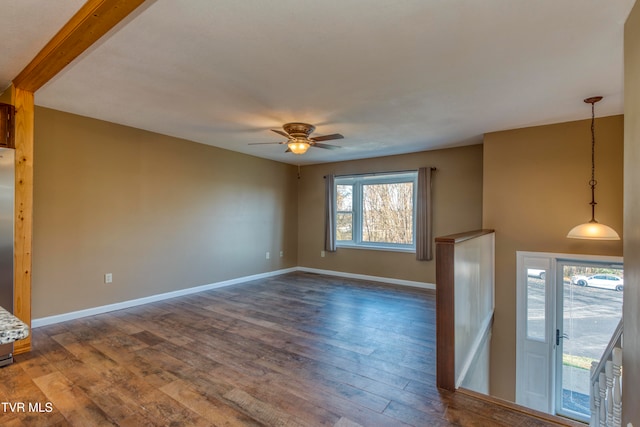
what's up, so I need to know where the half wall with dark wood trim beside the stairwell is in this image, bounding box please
[435,230,495,393]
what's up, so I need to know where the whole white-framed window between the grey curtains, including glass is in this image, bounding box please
[335,172,418,251]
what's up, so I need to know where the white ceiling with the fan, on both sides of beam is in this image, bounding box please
[0,0,635,164]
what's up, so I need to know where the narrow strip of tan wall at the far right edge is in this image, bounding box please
[622,3,640,426]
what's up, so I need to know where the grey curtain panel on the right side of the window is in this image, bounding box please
[416,168,433,261]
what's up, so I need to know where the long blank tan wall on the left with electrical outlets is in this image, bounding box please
[32,108,298,318]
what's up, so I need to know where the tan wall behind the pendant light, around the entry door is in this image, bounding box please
[483,114,626,401]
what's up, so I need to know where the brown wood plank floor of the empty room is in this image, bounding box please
[0,273,576,427]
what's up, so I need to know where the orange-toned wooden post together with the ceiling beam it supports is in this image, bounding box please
[11,0,148,354]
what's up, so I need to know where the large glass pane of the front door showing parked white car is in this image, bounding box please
[557,264,624,421]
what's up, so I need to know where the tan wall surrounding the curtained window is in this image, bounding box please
[298,145,482,283]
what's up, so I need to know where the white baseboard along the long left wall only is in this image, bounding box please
[31,267,297,328]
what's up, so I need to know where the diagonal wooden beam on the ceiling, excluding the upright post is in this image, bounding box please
[13,0,145,92]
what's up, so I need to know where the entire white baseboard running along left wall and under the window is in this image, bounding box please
[31,267,436,328]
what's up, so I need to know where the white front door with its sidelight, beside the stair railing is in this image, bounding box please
[516,252,624,421]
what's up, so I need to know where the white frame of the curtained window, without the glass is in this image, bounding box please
[334,171,418,252]
